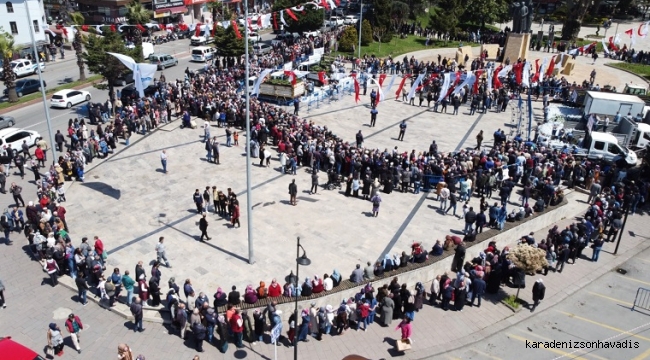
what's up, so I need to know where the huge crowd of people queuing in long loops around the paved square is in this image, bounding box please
[0,19,648,357]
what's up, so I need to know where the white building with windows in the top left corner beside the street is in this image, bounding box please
[0,0,48,47]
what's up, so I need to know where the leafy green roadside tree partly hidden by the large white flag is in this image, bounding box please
[83,31,143,102]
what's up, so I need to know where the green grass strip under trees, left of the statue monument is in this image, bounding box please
[334,35,466,58]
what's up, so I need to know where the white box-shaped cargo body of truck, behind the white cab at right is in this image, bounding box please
[583,91,645,119]
